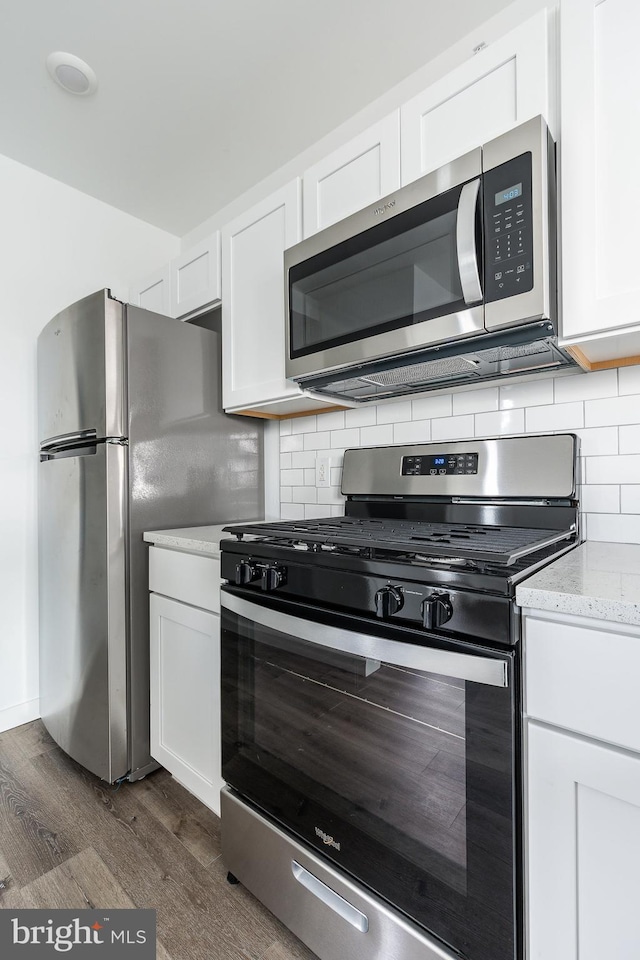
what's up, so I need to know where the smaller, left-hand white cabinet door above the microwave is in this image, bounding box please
[302,110,400,237]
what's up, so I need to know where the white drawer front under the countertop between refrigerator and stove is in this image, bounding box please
[149,547,220,613]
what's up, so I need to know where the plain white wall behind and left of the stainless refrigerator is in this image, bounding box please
[0,156,179,731]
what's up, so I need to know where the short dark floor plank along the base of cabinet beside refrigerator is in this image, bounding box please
[133,770,222,867]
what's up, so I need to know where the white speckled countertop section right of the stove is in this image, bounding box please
[516,540,640,626]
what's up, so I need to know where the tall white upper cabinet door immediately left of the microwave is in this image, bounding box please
[222,178,301,409]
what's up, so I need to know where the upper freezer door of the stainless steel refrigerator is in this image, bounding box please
[38,290,127,441]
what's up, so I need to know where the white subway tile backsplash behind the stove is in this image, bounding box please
[280,366,640,543]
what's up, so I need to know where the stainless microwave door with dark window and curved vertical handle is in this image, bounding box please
[285,160,484,379]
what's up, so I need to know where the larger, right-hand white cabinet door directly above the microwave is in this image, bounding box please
[400,10,553,184]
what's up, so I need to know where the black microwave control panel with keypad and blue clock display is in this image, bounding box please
[483,153,533,302]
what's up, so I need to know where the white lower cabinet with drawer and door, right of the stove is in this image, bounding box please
[524,611,640,960]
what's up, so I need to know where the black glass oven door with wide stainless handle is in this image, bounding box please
[222,586,520,960]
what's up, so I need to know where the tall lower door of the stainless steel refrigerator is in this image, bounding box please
[39,443,128,782]
